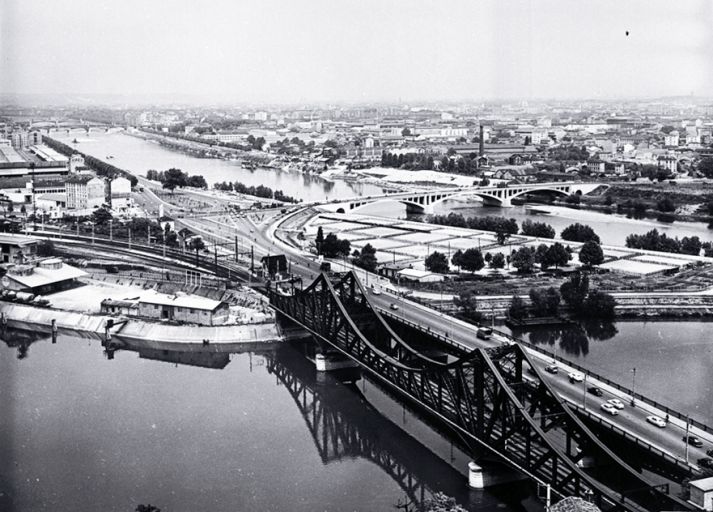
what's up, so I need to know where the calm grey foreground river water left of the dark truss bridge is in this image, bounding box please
[0,331,541,512]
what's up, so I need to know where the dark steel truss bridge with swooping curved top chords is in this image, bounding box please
[267,272,692,512]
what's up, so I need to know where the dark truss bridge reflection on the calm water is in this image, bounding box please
[266,346,526,510]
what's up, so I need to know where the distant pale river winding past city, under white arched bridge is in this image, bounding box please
[51,130,713,245]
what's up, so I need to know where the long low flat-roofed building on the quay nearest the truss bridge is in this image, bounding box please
[101,292,230,325]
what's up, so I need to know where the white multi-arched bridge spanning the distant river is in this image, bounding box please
[323,181,601,213]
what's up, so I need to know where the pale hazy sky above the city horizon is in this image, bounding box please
[0,0,713,102]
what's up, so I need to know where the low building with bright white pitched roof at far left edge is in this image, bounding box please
[0,258,87,295]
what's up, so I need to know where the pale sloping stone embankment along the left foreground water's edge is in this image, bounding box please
[0,302,285,346]
